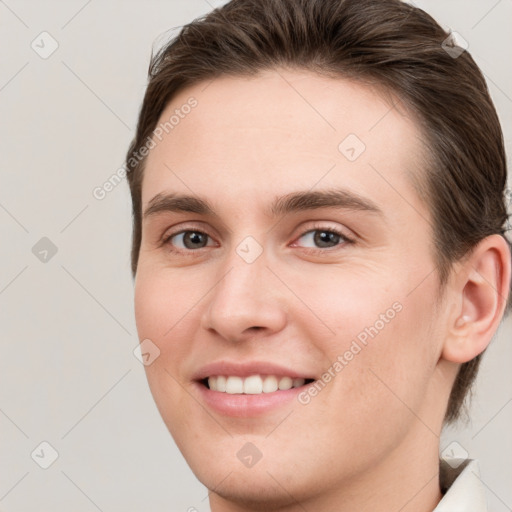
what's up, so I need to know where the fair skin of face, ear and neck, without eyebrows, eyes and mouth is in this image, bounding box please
[131,70,510,512]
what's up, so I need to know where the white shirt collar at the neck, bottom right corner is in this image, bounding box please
[433,459,487,512]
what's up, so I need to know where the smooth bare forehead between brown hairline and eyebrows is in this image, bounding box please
[142,70,424,221]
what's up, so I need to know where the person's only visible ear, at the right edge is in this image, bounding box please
[441,235,511,363]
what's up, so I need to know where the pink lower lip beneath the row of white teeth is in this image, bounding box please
[194,382,310,418]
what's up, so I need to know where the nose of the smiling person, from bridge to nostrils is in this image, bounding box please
[201,253,286,342]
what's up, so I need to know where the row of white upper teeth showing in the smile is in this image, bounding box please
[208,375,306,395]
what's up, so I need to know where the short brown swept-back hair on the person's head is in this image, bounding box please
[126,0,510,422]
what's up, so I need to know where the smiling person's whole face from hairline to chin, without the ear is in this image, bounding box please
[135,70,445,510]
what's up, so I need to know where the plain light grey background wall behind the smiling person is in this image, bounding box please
[0,0,512,512]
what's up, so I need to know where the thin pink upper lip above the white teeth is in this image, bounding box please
[192,361,316,380]
